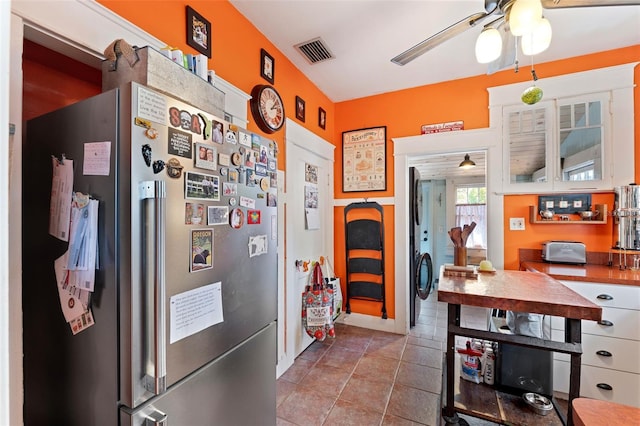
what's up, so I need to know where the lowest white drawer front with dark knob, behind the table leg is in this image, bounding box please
[553,360,640,407]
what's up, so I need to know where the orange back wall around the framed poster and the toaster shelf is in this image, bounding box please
[334,45,640,316]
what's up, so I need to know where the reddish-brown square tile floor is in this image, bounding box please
[277,291,492,426]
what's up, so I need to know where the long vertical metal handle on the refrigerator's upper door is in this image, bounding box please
[140,181,167,392]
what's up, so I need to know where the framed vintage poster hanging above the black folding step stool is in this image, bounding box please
[342,126,387,192]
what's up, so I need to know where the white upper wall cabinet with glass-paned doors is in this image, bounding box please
[489,64,635,193]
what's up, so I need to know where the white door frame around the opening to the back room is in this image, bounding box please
[393,128,504,333]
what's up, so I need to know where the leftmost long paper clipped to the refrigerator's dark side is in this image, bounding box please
[49,156,73,241]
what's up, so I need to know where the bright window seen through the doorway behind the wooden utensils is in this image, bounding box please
[456,184,487,249]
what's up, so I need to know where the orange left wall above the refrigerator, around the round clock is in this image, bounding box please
[98,0,335,171]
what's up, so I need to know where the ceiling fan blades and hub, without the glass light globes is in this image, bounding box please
[391,0,640,66]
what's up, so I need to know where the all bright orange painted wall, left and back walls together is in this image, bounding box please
[98,0,640,318]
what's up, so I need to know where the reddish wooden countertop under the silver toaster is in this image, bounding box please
[521,260,640,286]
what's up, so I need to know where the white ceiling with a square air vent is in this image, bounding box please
[231,0,640,102]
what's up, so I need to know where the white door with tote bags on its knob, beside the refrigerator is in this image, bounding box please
[277,119,335,377]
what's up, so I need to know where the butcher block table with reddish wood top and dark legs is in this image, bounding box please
[438,267,602,426]
